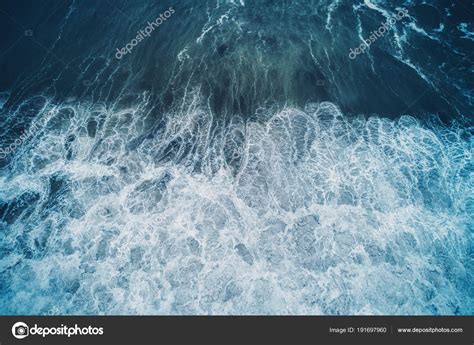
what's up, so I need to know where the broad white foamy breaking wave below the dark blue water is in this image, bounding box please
[0,93,474,314]
